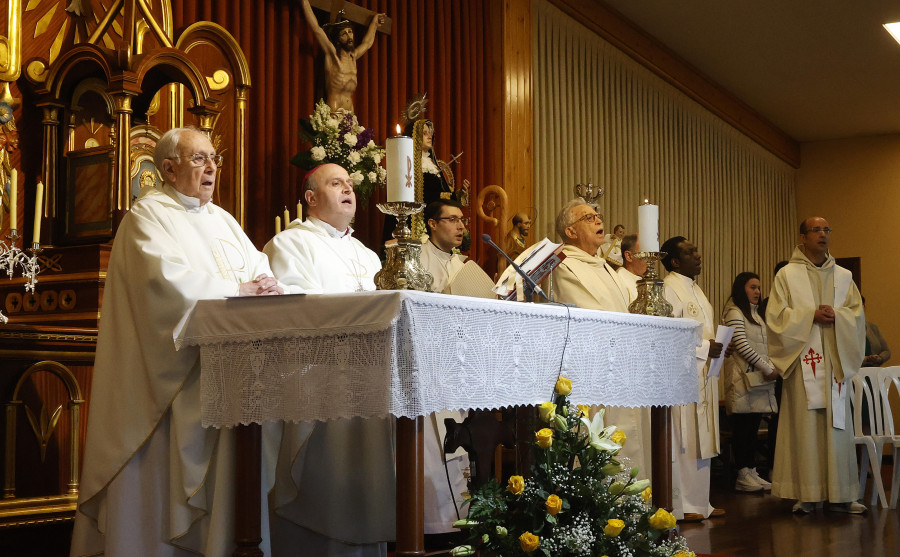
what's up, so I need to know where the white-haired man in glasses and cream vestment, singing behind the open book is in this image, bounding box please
[553,198,650,477]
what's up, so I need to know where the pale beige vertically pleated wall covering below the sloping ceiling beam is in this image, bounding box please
[533,2,796,311]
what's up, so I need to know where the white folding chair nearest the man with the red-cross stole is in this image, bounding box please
[850,368,890,507]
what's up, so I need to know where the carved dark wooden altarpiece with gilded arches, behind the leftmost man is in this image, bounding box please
[0,0,250,554]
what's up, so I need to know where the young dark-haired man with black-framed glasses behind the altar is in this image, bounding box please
[419,199,469,292]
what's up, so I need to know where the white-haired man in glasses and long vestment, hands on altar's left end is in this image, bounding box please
[71,129,282,557]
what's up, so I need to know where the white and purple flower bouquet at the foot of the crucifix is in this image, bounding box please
[291,100,387,205]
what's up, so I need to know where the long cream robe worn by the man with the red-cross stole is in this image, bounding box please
[766,247,866,503]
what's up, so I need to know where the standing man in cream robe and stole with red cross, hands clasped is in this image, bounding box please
[766,217,868,514]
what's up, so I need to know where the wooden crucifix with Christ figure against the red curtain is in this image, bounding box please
[303,0,391,112]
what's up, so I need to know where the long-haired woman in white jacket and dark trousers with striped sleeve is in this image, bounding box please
[722,272,778,491]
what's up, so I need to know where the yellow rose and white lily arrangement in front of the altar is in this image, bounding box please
[451,377,694,557]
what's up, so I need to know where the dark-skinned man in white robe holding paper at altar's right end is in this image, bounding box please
[660,236,725,522]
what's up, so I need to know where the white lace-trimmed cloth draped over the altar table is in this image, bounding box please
[175,291,700,427]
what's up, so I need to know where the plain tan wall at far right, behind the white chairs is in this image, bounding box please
[793,134,900,350]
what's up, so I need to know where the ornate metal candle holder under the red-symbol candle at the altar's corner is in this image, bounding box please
[375,201,434,292]
